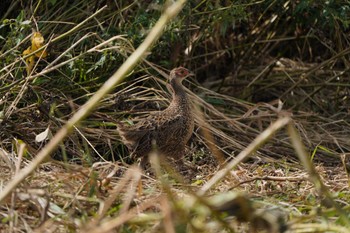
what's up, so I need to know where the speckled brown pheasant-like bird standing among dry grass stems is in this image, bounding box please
[117,67,194,166]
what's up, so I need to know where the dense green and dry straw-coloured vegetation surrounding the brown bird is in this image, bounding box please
[0,0,350,232]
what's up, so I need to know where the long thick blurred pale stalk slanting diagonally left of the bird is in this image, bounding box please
[0,0,186,203]
